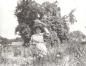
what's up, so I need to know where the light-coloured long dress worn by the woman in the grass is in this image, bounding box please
[31,33,47,55]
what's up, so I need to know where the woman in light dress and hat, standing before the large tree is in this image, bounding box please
[30,20,50,57]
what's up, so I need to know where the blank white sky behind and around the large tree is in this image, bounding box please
[0,0,86,39]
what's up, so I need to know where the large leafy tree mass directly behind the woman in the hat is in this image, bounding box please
[15,0,75,45]
